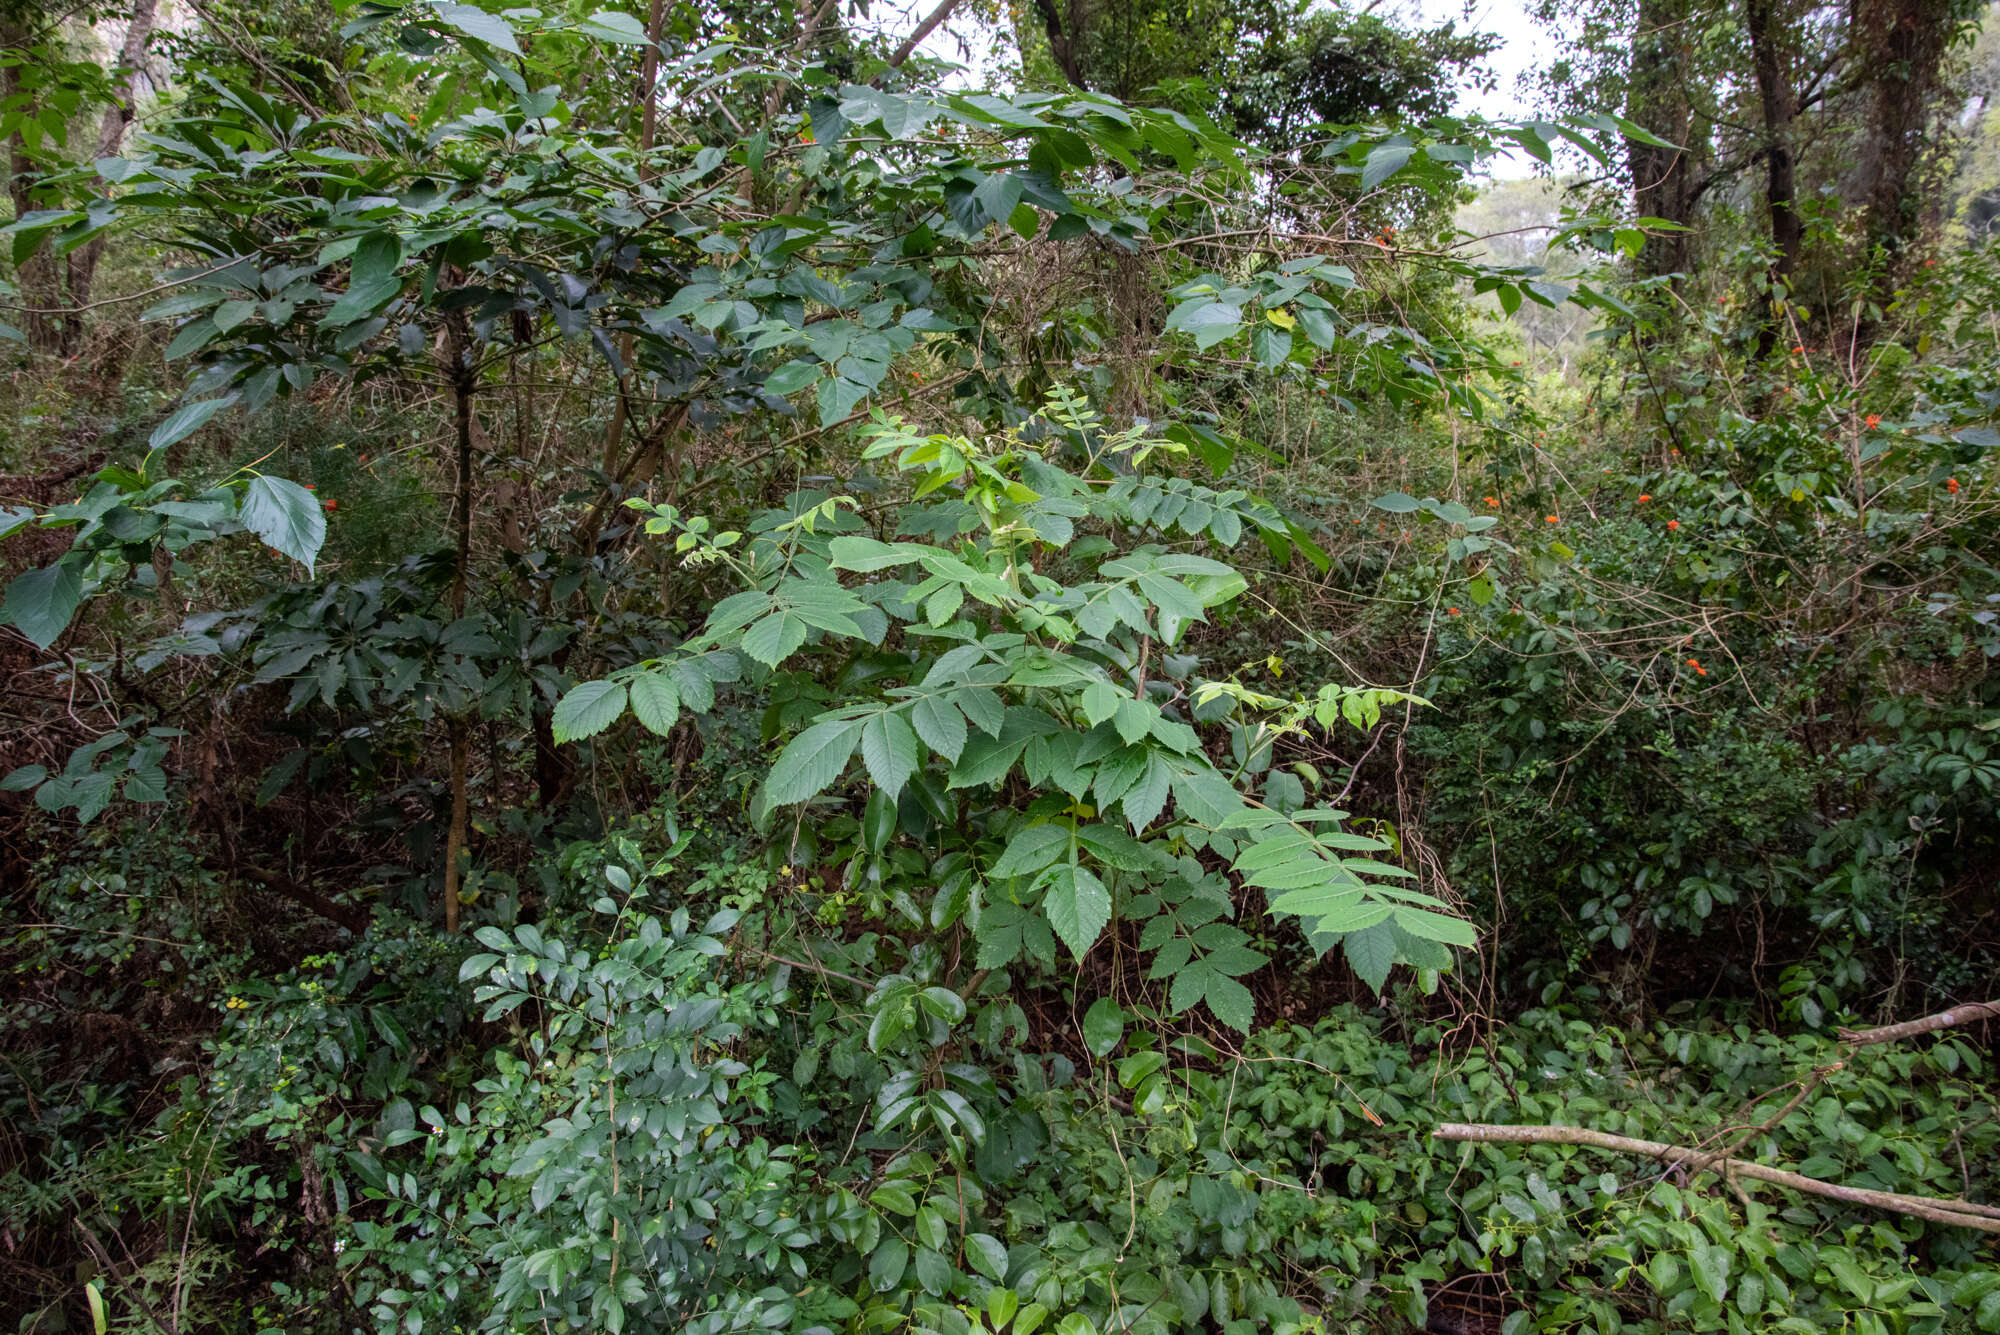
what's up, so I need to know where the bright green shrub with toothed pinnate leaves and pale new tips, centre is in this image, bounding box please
[556,392,1472,1031]
